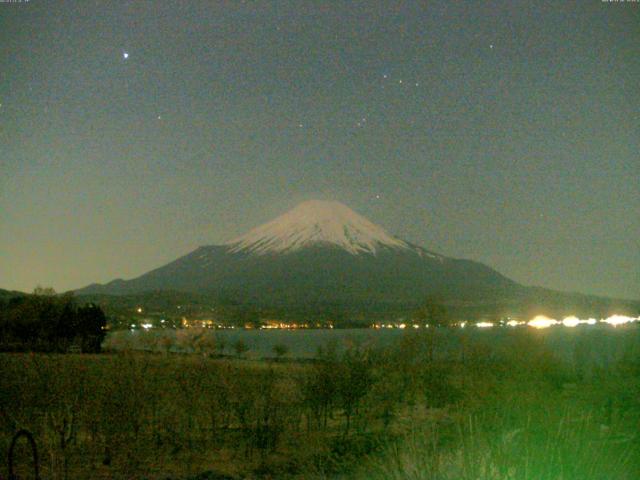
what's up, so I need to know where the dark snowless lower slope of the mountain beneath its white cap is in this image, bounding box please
[78,246,519,304]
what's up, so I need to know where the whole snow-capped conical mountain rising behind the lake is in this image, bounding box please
[76,200,636,311]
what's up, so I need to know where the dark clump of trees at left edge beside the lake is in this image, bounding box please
[0,288,106,352]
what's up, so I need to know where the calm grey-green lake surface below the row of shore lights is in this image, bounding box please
[104,323,640,365]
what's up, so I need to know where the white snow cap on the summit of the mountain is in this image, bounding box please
[227,200,411,255]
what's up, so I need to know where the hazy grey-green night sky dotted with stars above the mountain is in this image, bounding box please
[0,0,640,299]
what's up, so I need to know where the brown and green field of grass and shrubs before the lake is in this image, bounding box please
[0,327,640,480]
